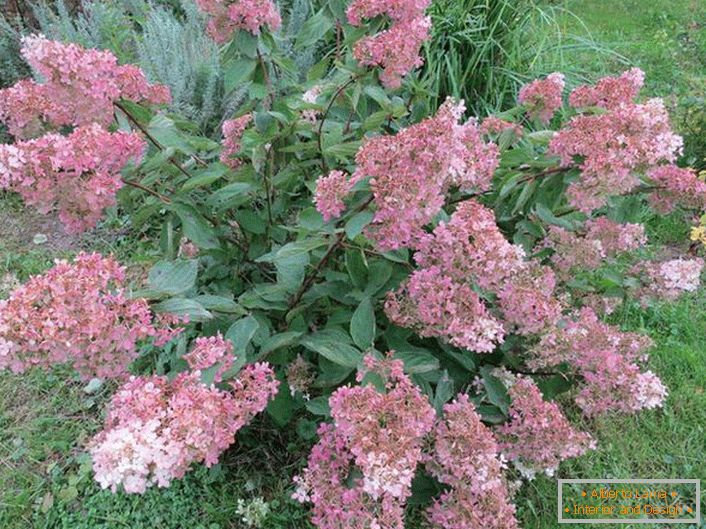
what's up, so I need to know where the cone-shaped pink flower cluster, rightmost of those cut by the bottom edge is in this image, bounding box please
[426,394,518,529]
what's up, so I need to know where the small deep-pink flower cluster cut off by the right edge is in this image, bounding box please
[647,165,706,213]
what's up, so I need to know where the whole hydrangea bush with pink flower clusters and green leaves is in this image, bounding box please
[0,0,706,529]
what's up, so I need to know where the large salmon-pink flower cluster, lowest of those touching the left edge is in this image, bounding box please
[0,253,181,379]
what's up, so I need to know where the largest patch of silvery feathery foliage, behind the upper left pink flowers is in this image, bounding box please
[20,0,228,132]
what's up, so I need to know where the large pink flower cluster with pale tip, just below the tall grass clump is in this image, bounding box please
[351,100,498,250]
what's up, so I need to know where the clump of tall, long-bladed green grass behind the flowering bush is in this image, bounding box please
[421,0,611,113]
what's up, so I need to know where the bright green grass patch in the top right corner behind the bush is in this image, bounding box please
[558,0,706,169]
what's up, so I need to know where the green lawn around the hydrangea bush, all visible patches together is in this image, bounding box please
[0,0,706,529]
